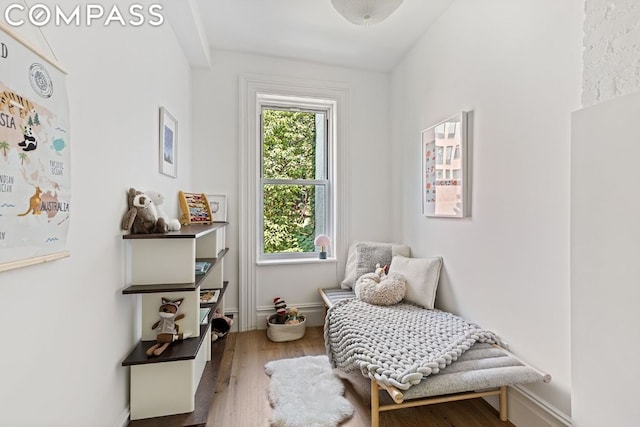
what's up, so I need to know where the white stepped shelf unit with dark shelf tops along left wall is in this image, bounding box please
[122,222,228,425]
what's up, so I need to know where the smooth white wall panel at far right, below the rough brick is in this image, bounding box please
[571,93,640,427]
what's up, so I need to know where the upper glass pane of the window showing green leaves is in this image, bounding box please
[262,108,326,179]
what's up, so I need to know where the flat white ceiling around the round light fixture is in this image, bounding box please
[167,0,453,71]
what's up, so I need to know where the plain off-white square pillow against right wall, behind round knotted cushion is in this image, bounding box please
[389,255,442,308]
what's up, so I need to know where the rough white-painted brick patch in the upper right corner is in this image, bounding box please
[582,0,640,107]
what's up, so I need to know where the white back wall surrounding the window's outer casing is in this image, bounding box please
[192,50,392,332]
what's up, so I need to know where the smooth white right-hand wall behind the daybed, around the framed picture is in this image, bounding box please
[391,0,584,426]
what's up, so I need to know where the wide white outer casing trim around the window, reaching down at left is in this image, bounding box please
[240,74,351,331]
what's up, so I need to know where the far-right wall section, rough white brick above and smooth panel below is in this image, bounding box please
[571,0,640,427]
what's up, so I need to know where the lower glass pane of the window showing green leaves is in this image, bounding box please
[263,184,325,254]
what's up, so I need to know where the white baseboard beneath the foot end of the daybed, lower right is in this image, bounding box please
[485,385,572,427]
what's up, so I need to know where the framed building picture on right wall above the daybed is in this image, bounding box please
[421,111,470,218]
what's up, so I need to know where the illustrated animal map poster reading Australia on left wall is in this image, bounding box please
[0,28,71,271]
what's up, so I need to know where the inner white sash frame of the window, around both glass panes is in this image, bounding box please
[256,94,336,263]
